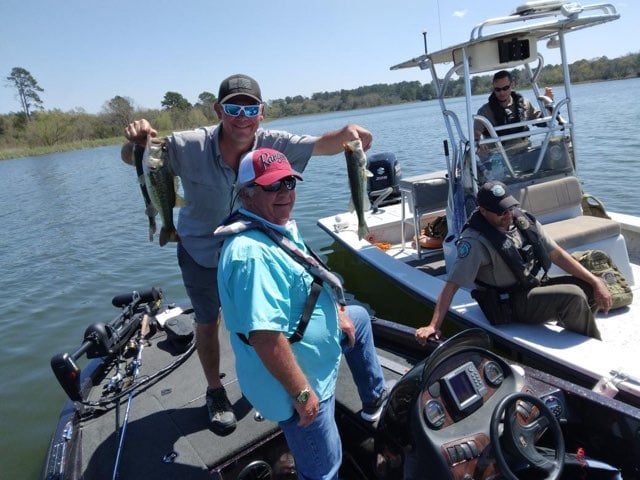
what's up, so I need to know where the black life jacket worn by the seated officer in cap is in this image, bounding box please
[462,208,551,290]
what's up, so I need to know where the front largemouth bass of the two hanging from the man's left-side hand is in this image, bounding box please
[142,137,182,246]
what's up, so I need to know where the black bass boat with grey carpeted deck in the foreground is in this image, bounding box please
[42,288,640,480]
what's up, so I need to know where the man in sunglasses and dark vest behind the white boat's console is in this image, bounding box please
[473,70,553,154]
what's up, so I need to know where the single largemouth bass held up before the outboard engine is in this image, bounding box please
[343,140,373,240]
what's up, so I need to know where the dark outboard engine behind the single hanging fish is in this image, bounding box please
[367,152,402,212]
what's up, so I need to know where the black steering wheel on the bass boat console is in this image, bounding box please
[490,392,565,480]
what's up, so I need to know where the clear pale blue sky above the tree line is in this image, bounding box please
[0,0,640,113]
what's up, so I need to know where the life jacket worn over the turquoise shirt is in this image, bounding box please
[213,211,346,345]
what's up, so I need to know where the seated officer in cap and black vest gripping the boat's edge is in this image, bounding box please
[415,181,612,345]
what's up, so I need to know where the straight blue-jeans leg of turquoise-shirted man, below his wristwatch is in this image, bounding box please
[279,395,342,480]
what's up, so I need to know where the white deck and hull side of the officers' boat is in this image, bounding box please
[318,209,640,405]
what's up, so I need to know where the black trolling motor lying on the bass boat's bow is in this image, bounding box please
[51,287,162,402]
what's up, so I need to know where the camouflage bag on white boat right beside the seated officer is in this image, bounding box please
[571,250,633,310]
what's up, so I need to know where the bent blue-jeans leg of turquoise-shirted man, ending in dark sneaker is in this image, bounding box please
[342,305,385,404]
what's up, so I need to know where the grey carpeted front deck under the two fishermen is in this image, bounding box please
[52,314,412,479]
